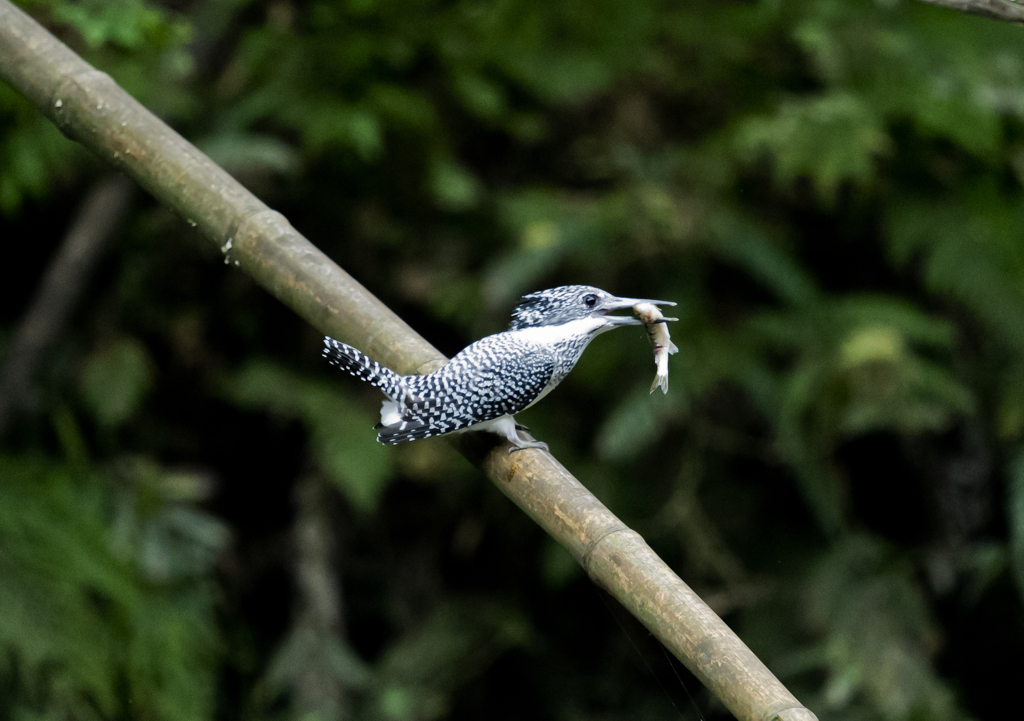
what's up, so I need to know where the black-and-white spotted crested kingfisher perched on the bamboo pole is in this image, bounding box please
[324,286,675,453]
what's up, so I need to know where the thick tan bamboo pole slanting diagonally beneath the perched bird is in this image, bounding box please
[0,0,815,721]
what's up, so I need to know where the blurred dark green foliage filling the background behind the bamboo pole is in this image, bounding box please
[0,0,1024,721]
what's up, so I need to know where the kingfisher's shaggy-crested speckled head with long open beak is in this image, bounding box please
[509,286,675,331]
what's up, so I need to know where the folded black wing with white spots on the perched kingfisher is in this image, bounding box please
[377,333,555,443]
